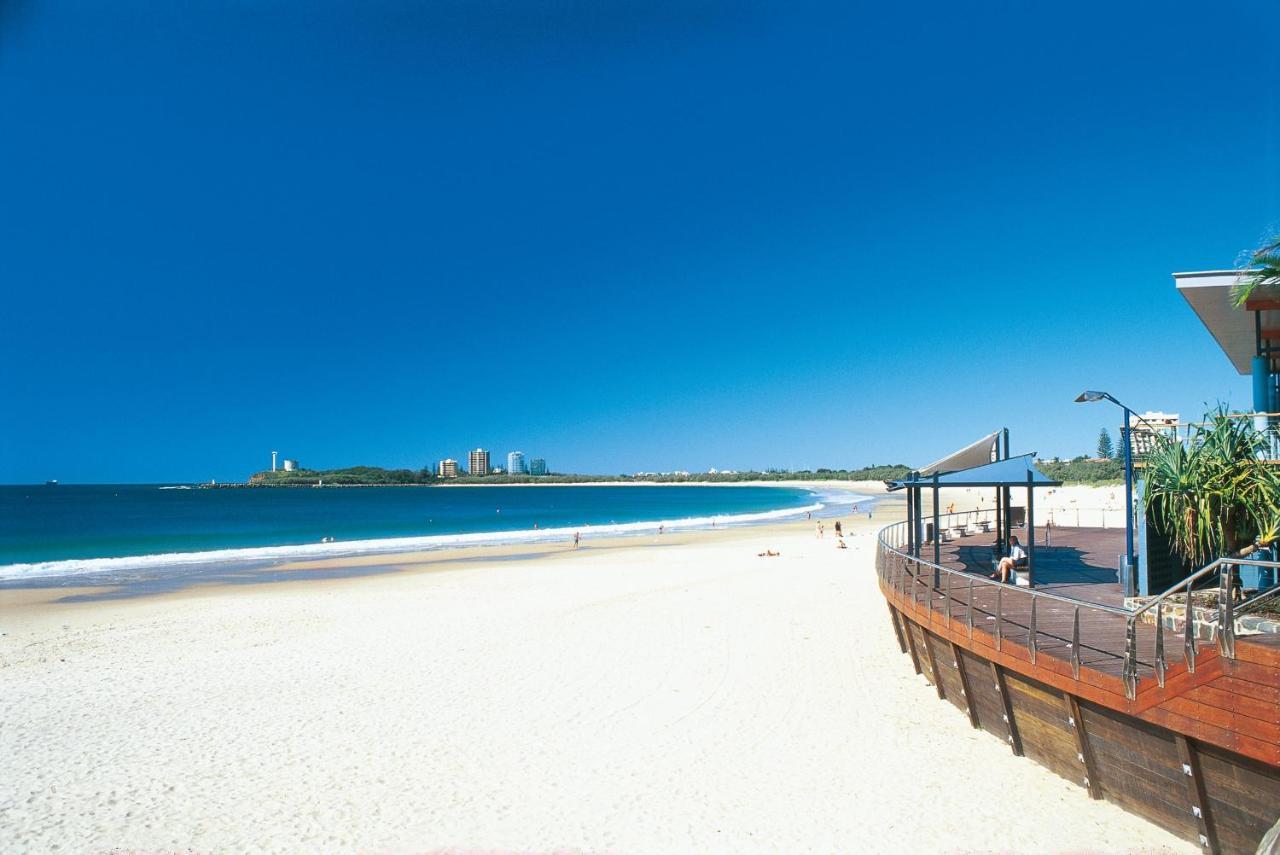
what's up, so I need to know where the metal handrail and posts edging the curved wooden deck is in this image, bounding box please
[877,508,1280,699]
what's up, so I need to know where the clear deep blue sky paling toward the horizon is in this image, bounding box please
[0,0,1280,483]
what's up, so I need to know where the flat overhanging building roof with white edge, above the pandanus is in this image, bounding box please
[1174,270,1280,374]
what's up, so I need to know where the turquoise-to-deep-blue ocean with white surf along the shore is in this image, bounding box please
[0,484,870,585]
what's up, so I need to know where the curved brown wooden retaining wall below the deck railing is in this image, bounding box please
[884,604,1280,854]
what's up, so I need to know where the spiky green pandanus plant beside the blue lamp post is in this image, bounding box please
[1146,408,1280,564]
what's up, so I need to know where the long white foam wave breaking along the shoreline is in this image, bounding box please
[0,494,839,581]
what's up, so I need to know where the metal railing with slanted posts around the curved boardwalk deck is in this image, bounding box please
[876,511,1280,700]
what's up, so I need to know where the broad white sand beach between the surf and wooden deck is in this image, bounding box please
[0,490,1196,852]
